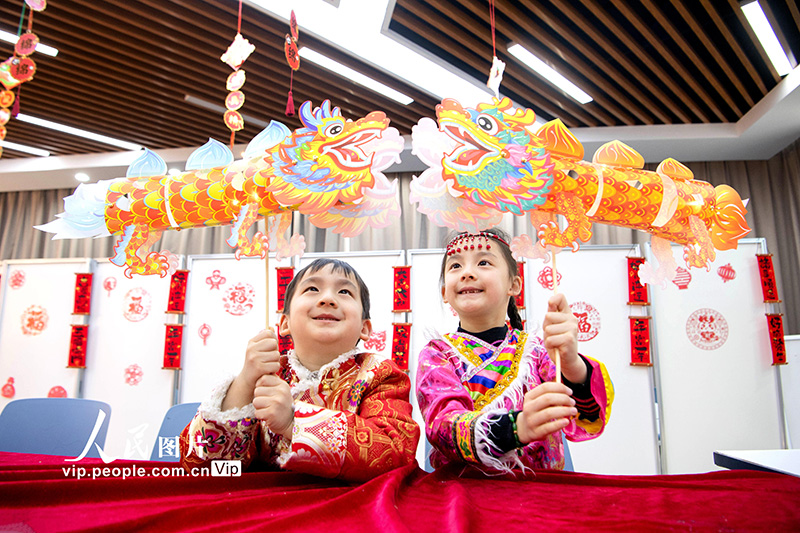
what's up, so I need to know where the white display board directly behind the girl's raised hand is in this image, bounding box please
[525,246,660,475]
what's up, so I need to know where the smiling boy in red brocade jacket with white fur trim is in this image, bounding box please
[181,259,419,482]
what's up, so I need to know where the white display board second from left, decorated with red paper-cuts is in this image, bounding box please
[83,260,175,459]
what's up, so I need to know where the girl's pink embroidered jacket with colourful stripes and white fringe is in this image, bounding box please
[416,329,614,471]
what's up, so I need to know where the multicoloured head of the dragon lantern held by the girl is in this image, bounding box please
[436,98,553,214]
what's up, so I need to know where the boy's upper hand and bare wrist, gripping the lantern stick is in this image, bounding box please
[221,329,281,411]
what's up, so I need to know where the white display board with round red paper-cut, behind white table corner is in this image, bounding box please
[647,239,783,474]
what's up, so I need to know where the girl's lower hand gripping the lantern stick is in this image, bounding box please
[517,381,578,444]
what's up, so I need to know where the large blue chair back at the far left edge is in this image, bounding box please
[0,398,111,457]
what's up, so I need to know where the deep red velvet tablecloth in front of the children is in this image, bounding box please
[0,453,800,533]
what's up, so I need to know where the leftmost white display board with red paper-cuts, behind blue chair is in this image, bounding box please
[0,259,91,410]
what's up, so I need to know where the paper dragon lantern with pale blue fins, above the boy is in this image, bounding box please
[36,100,404,277]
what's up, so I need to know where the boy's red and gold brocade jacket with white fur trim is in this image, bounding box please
[180,350,420,482]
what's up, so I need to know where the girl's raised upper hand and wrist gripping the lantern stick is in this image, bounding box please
[542,293,586,383]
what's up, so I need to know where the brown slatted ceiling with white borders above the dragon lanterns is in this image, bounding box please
[0,0,800,190]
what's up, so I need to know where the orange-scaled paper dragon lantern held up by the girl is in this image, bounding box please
[409,98,750,268]
